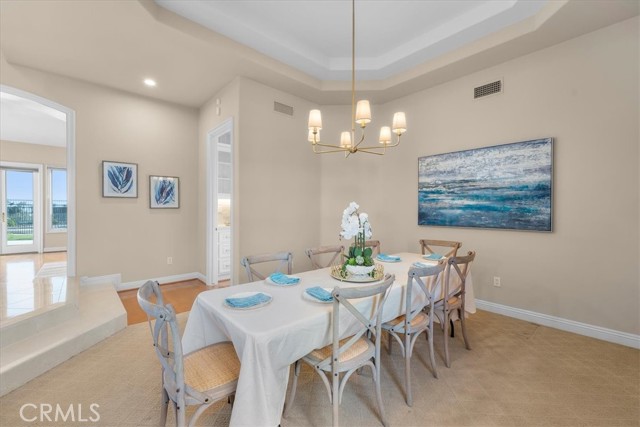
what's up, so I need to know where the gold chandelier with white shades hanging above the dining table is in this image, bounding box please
[308,0,407,157]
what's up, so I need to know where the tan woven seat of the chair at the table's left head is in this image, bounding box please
[184,342,240,392]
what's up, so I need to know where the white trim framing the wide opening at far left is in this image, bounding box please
[0,84,76,277]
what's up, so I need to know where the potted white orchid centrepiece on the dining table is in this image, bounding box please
[340,202,375,275]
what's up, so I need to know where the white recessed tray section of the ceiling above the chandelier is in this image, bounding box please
[155,0,547,80]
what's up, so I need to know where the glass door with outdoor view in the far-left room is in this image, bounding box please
[0,167,41,254]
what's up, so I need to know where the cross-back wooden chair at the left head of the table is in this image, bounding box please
[138,280,240,427]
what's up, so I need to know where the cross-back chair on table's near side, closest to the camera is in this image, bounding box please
[285,275,395,426]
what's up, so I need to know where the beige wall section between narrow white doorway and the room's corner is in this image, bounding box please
[234,79,322,282]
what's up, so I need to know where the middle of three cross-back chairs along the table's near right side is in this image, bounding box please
[382,259,447,406]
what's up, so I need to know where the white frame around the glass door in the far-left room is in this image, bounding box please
[0,161,44,255]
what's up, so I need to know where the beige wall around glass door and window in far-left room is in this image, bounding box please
[0,141,67,250]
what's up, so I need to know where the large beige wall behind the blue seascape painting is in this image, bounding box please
[322,18,640,334]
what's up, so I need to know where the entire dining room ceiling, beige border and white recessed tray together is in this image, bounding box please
[0,0,640,108]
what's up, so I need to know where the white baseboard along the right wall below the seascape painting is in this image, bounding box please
[476,300,640,349]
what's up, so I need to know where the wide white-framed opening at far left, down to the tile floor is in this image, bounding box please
[0,85,76,276]
